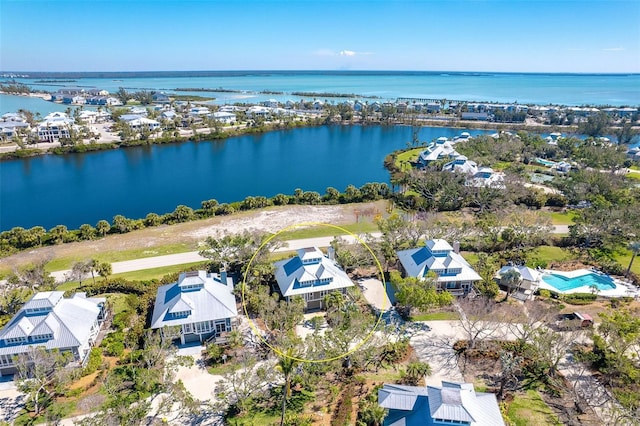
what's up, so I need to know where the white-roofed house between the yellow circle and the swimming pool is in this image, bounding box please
[397,239,481,296]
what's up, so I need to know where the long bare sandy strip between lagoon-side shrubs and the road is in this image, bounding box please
[0,201,386,269]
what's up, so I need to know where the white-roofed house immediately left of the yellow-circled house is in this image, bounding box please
[151,270,238,345]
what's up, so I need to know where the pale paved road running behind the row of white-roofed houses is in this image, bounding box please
[51,225,569,282]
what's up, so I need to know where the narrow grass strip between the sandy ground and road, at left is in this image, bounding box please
[45,243,197,272]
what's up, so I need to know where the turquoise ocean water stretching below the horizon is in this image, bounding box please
[0,71,640,112]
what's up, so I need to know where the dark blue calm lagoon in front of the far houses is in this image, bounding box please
[0,126,492,230]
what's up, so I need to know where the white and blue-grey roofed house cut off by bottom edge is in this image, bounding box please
[378,381,504,426]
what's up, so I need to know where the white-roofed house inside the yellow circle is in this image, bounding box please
[274,247,353,310]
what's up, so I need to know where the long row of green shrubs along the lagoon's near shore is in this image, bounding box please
[0,182,391,256]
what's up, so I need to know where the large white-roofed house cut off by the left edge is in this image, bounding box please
[0,291,106,376]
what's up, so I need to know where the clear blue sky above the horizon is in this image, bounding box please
[0,0,640,73]
